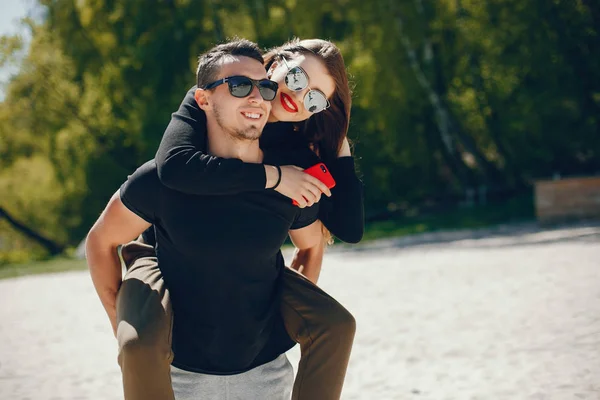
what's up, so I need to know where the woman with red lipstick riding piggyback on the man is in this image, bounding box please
[117,39,363,399]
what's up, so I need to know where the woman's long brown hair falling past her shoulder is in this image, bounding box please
[264,39,352,244]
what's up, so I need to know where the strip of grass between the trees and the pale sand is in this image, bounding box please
[0,196,534,279]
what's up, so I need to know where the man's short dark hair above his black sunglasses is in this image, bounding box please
[196,38,264,88]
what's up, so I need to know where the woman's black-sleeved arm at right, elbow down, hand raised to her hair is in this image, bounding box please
[319,140,365,243]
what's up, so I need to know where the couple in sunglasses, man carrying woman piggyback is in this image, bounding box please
[86,39,363,399]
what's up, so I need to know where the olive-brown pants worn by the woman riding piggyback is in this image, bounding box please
[117,241,356,400]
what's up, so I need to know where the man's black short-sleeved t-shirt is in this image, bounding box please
[120,151,318,374]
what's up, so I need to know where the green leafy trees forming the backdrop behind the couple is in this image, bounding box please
[0,0,600,260]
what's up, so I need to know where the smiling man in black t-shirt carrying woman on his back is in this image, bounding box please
[86,40,321,399]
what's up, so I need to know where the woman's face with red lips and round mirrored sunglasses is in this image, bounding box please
[267,54,335,122]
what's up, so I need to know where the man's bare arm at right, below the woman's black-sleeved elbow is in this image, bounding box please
[290,221,325,285]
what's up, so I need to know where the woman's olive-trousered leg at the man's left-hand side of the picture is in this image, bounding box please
[117,239,175,400]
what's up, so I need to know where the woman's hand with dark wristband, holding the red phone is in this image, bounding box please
[265,165,331,208]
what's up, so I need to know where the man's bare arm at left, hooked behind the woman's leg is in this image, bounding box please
[85,191,151,336]
